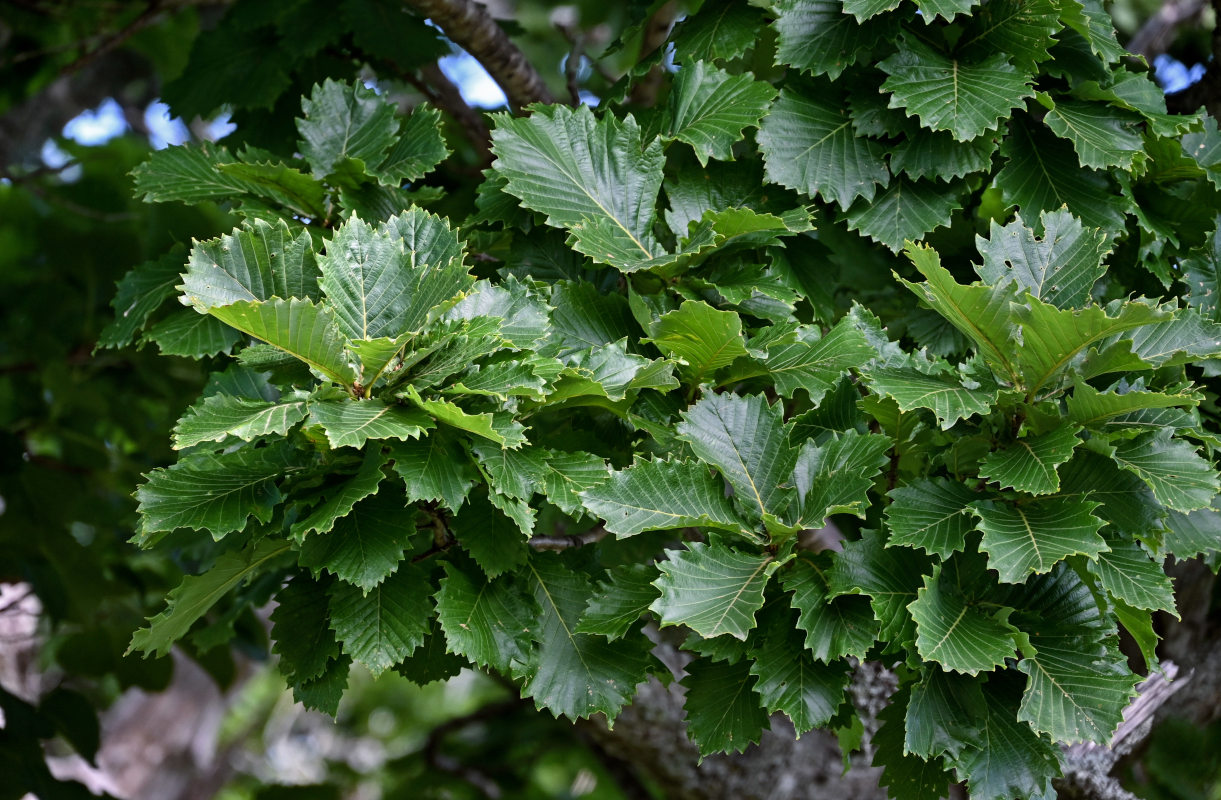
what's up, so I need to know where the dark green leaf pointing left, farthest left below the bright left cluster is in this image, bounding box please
[136,447,291,541]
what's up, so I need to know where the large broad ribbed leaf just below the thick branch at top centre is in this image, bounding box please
[492,106,664,260]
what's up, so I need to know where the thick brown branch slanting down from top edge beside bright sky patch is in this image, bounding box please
[407,0,556,111]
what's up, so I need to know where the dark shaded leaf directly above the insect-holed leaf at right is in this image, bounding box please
[996,116,1123,233]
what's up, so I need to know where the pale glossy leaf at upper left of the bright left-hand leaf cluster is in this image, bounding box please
[181,220,317,311]
